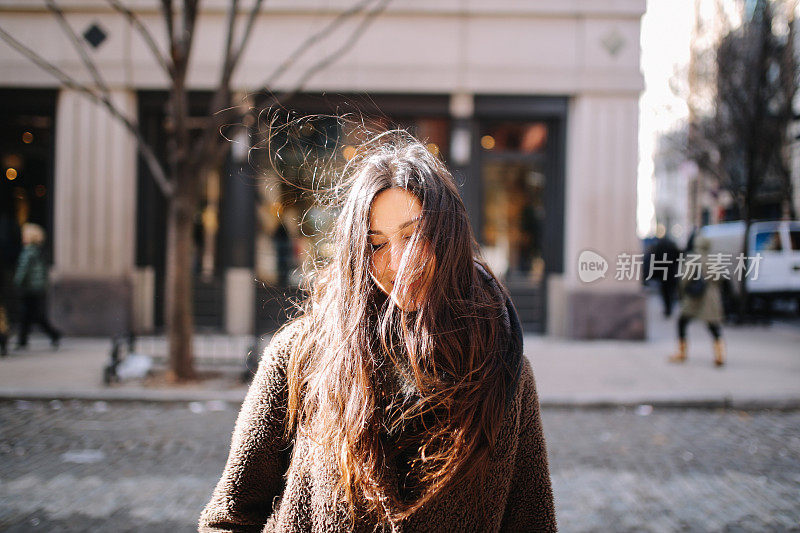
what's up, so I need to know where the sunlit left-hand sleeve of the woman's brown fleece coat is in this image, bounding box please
[198,326,297,532]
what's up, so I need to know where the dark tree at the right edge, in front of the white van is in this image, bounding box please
[685,0,799,316]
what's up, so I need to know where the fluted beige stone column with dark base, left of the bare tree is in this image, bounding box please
[51,89,136,335]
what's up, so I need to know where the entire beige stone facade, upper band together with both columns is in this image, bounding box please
[0,0,645,333]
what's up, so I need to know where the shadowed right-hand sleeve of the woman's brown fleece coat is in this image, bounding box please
[501,358,556,532]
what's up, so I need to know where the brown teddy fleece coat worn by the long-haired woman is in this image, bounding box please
[199,274,556,533]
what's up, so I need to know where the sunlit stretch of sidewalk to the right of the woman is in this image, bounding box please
[525,295,800,408]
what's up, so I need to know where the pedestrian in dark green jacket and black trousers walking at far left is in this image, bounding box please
[14,222,61,348]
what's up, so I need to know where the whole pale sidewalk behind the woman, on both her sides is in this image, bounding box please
[0,295,800,410]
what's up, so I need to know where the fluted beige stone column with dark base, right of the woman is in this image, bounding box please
[548,94,646,339]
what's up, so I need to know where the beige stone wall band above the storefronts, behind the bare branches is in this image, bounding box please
[0,0,645,95]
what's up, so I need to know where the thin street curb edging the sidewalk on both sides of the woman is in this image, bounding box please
[0,388,800,414]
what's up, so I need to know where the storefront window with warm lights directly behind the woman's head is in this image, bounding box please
[255,116,449,287]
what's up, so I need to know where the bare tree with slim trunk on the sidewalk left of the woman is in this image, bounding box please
[0,0,390,380]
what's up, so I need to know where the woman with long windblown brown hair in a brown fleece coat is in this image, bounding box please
[200,133,556,532]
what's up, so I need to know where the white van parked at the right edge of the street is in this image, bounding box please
[699,220,800,305]
